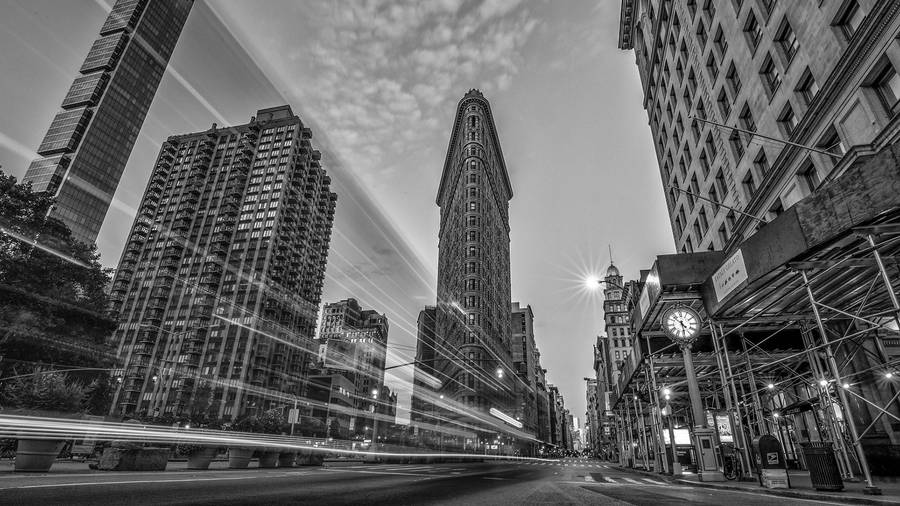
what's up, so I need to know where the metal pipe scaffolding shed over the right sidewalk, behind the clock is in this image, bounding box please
[614,146,900,493]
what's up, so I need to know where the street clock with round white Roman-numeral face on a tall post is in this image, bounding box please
[661,307,725,481]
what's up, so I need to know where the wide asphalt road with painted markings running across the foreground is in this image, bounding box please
[0,459,844,506]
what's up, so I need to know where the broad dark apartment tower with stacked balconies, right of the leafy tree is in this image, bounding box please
[111,105,337,420]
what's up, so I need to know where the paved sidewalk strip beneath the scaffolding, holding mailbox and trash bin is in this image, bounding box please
[614,464,900,505]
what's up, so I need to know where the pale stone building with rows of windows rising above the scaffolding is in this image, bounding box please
[618,0,900,252]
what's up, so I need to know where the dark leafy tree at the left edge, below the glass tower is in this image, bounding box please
[0,171,115,411]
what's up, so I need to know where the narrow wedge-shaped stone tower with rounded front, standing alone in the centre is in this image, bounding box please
[435,90,516,432]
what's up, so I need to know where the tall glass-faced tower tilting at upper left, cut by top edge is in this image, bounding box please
[22,0,193,242]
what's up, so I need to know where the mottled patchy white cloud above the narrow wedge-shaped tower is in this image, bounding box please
[215,0,538,181]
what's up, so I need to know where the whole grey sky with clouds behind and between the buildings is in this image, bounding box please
[0,0,674,426]
